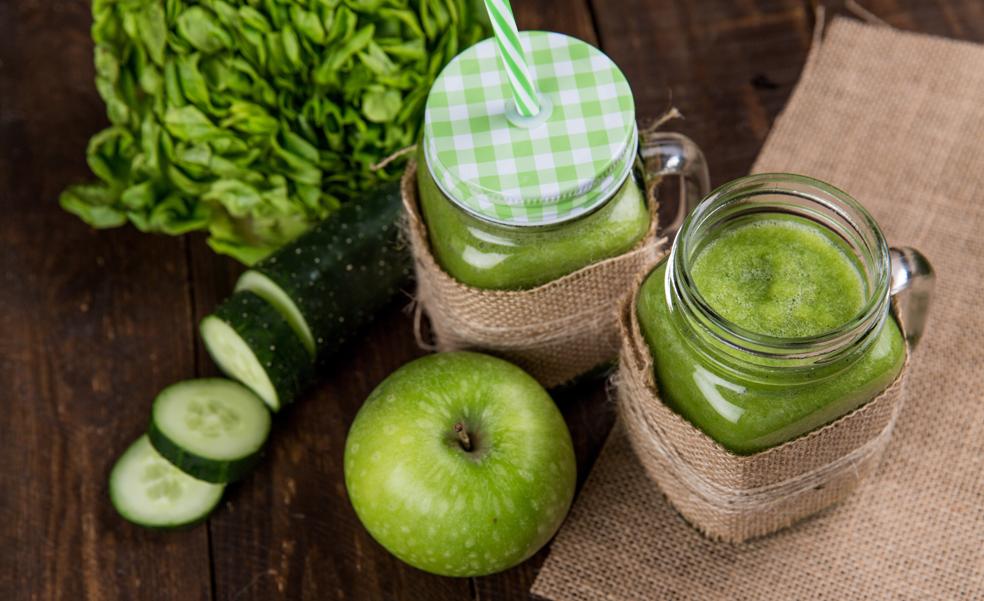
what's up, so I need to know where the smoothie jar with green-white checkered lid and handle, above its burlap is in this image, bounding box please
[417,31,708,290]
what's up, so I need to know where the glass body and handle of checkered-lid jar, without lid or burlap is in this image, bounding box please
[417,132,710,290]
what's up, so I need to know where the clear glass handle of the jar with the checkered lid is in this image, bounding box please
[639,131,711,238]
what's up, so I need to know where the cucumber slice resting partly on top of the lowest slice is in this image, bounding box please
[147,378,270,483]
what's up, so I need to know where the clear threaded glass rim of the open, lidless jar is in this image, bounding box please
[666,173,891,366]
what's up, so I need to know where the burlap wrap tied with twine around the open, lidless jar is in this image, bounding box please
[617,270,909,543]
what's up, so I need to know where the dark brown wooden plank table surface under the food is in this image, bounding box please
[0,0,984,601]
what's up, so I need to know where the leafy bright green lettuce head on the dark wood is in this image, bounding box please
[59,0,489,264]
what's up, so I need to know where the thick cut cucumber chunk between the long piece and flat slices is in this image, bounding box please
[199,291,314,411]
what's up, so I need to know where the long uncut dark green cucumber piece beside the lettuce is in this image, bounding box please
[236,182,411,359]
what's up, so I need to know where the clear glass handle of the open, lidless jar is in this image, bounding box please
[888,246,936,348]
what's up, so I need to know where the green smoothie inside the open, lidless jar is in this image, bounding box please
[637,214,905,454]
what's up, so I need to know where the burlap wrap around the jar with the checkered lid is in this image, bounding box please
[402,162,666,388]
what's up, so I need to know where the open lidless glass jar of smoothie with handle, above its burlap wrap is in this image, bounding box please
[636,174,933,454]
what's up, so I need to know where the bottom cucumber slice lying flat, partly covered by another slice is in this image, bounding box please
[109,435,225,528]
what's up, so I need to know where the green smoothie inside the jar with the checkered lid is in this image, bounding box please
[417,152,650,290]
